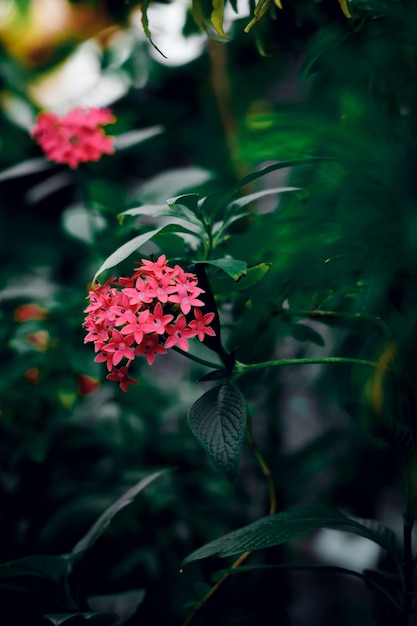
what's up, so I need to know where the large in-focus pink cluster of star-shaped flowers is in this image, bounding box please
[84,255,216,391]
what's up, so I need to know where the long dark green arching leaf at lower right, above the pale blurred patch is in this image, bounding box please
[184,505,399,563]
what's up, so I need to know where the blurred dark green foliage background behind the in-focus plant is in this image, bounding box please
[0,0,417,626]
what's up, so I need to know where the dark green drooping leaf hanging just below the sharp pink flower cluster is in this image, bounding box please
[188,381,247,482]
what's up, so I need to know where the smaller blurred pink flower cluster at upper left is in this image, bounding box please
[31,108,116,169]
